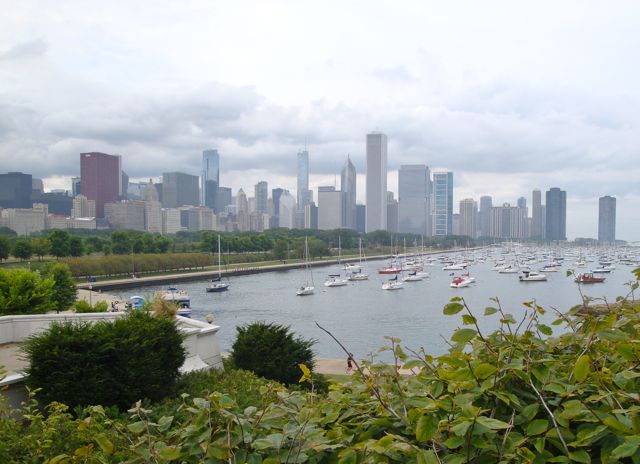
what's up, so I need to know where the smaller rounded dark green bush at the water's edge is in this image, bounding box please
[231,322,315,385]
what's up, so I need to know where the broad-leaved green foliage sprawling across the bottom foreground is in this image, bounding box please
[0,270,640,464]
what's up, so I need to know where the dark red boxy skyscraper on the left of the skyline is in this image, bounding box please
[80,152,122,218]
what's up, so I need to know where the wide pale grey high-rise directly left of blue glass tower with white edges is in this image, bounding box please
[398,164,429,235]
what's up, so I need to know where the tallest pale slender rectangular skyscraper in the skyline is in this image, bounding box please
[366,132,387,232]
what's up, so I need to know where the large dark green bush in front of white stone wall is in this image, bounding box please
[23,311,185,409]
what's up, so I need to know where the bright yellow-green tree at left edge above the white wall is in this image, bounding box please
[0,269,56,316]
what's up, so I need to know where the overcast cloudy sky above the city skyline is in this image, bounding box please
[0,0,640,241]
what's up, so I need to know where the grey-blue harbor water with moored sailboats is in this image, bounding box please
[121,261,634,359]
